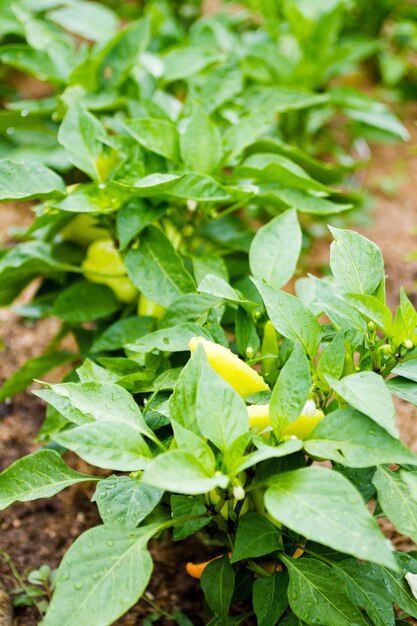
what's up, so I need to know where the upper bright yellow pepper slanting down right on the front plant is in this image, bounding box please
[190,337,269,398]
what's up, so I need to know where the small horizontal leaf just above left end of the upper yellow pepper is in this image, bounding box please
[125,322,212,352]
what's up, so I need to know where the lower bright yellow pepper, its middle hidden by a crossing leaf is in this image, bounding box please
[248,400,324,439]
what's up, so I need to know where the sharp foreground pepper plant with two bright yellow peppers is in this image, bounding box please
[0,222,417,626]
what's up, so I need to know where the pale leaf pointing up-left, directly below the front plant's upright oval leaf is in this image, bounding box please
[253,280,321,358]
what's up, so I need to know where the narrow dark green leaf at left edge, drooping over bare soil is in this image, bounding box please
[0,352,77,402]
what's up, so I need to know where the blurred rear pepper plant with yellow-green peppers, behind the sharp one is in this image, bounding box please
[0,2,406,399]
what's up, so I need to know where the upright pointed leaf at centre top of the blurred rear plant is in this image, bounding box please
[181,103,222,174]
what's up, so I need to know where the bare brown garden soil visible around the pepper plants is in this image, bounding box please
[0,107,417,626]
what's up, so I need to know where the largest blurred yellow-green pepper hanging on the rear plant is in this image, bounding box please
[81,239,138,304]
